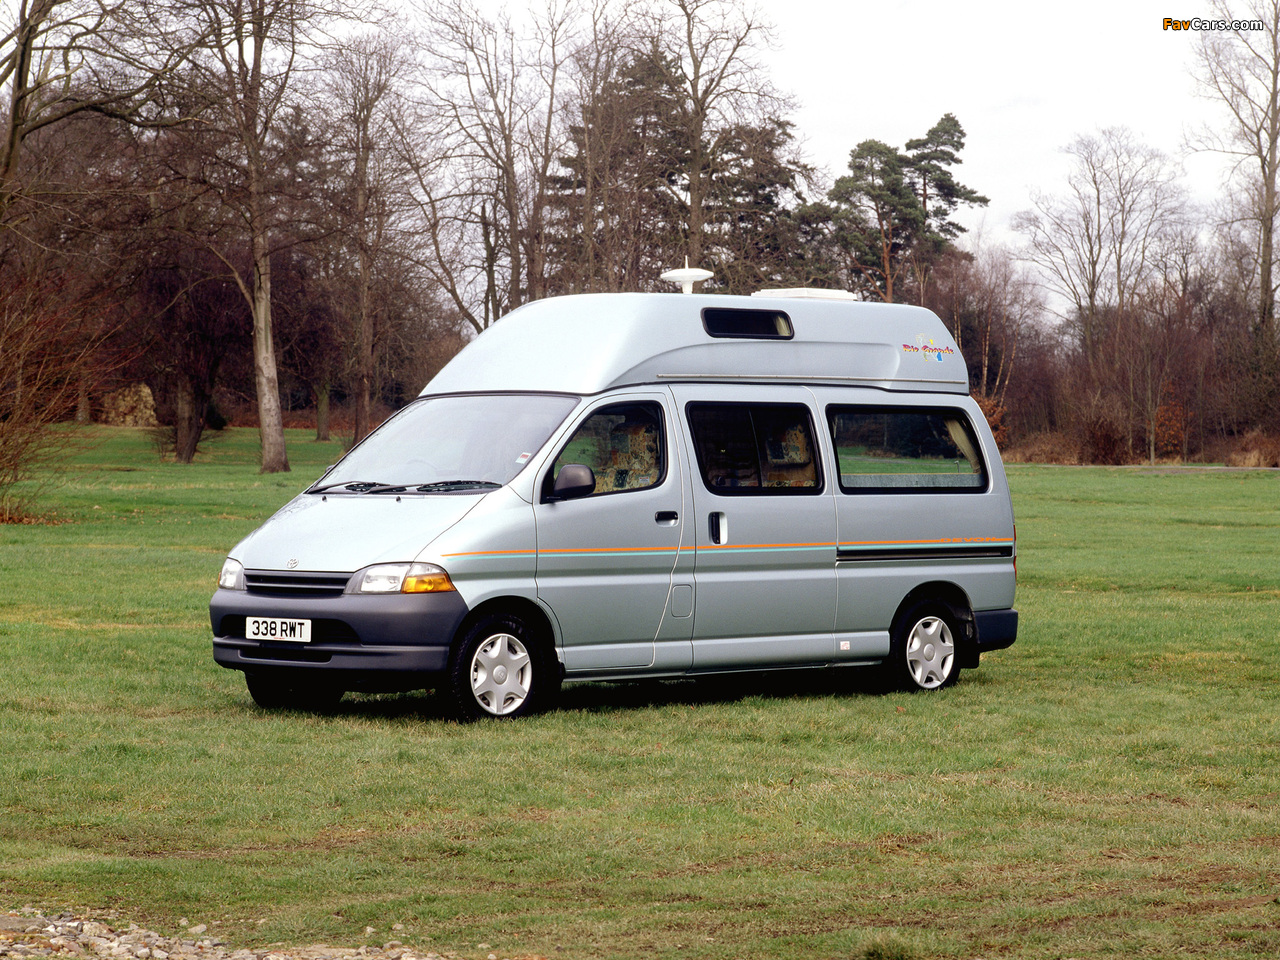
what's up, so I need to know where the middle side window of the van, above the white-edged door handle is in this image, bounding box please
[686,403,822,495]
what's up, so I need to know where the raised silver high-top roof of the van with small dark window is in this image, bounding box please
[422,293,969,394]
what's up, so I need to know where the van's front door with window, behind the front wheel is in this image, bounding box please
[534,392,692,673]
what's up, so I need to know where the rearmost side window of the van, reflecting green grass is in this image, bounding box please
[827,407,987,493]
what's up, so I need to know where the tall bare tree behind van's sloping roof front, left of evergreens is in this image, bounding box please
[408,0,575,330]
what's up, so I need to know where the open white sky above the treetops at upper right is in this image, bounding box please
[758,0,1244,248]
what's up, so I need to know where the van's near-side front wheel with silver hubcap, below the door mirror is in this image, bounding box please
[449,613,559,721]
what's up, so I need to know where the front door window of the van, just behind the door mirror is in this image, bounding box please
[545,403,666,497]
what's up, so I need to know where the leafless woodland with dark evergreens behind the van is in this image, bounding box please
[0,0,1280,514]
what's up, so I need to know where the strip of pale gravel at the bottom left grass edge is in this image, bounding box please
[0,908,524,960]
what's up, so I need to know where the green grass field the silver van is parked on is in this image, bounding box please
[0,429,1280,959]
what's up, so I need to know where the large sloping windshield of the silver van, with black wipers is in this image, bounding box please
[311,393,577,493]
